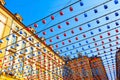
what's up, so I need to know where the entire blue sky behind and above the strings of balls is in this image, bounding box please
[3,0,120,80]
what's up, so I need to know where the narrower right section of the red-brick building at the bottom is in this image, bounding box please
[90,57,108,80]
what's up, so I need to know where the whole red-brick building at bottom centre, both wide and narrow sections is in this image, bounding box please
[63,56,108,80]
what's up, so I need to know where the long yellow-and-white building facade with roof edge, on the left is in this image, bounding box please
[0,0,64,80]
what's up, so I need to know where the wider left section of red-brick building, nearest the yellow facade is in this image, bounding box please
[64,56,93,80]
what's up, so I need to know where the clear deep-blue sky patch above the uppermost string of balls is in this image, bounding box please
[5,0,73,25]
